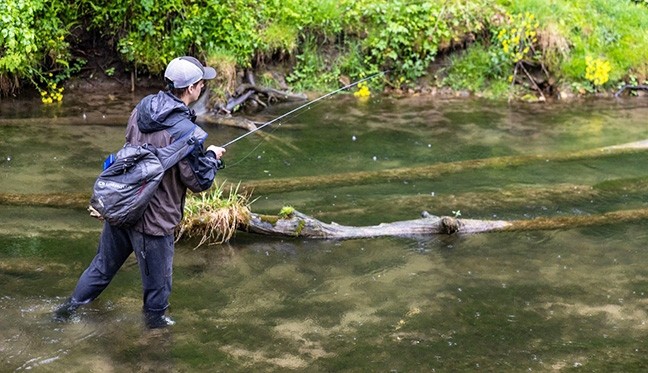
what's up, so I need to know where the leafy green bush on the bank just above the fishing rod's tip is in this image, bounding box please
[336,0,490,86]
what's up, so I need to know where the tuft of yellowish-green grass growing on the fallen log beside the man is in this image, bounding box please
[176,182,253,248]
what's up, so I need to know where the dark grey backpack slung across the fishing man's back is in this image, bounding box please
[89,126,198,227]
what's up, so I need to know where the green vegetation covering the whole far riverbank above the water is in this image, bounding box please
[0,0,648,103]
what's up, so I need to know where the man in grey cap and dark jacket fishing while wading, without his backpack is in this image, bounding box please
[55,56,225,328]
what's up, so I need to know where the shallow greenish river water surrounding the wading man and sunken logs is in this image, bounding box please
[0,91,648,372]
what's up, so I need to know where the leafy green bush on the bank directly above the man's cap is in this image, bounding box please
[82,0,259,73]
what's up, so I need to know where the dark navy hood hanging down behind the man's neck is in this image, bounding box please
[137,91,194,133]
